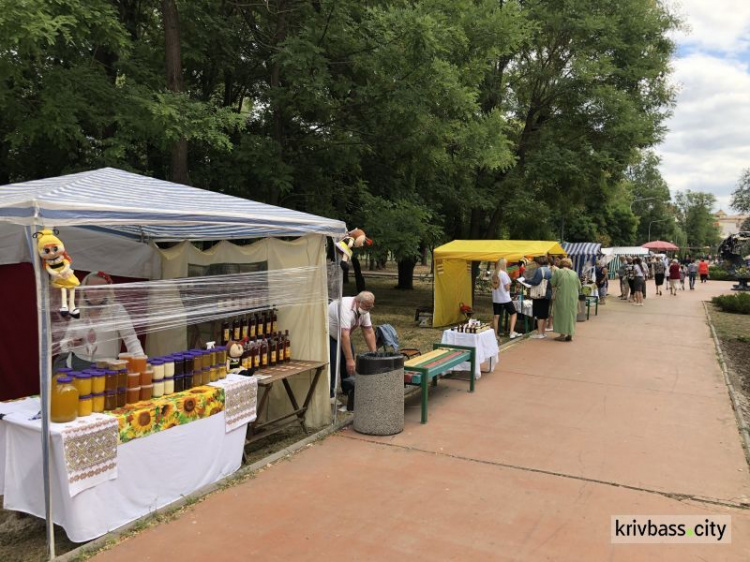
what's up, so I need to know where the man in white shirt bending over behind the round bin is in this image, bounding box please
[328,291,377,397]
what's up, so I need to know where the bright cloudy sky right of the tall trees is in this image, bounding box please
[656,0,750,213]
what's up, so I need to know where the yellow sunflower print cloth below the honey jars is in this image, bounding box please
[105,386,224,444]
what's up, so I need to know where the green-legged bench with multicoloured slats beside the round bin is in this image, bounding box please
[404,343,476,423]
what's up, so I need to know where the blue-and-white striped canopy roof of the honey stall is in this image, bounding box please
[0,164,346,241]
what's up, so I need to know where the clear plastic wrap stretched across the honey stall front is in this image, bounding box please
[50,266,327,358]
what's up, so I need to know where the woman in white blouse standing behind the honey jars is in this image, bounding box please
[60,271,144,369]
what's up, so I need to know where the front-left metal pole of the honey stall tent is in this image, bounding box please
[24,226,55,560]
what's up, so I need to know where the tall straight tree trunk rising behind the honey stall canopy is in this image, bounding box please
[161,0,190,185]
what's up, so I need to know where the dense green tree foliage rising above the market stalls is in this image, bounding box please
[0,0,692,280]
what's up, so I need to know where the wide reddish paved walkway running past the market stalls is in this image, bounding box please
[96,283,750,562]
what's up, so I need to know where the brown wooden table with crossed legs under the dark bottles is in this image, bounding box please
[245,360,328,454]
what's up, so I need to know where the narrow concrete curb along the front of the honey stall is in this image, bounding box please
[54,416,352,562]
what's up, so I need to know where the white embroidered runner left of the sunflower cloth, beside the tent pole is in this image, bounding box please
[60,414,117,497]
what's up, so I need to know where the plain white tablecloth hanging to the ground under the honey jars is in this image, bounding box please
[0,390,247,542]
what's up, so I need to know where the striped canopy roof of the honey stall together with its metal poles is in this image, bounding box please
[0,168,346,556]
